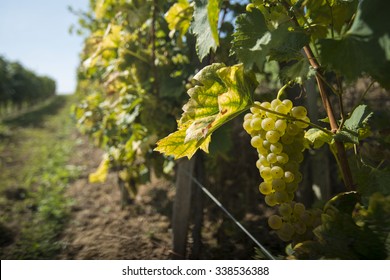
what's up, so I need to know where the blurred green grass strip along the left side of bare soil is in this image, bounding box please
[0,96,79,259]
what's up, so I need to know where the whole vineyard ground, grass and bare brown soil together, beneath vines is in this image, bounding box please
[0,96,281,259]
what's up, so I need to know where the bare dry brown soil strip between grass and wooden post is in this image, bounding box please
[58,137,173,260]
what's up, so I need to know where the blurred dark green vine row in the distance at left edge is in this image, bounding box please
[0,56,56,108]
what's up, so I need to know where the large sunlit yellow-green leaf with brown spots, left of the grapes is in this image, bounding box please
[155,64,257,159]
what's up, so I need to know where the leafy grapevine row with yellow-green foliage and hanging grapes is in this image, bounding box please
[71,0,390,258]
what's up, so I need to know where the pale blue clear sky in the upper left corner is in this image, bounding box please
[0,0,89,94]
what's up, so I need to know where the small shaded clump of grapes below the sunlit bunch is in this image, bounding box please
[268,201,322,241]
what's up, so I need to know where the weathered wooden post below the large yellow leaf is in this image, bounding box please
[172,155,196,259]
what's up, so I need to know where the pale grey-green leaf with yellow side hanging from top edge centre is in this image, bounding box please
[192,0,222,60]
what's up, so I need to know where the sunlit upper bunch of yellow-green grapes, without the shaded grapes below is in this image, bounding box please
[243,99,309,206]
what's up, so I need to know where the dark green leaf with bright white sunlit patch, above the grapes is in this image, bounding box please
[232,9,309,69]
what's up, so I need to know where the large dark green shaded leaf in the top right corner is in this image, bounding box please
[319,0,390,88]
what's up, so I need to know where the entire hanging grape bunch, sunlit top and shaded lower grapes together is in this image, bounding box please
[243,99,319,241]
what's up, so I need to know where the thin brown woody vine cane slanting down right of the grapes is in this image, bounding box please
[280,0,355,191]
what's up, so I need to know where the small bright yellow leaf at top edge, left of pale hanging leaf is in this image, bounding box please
[165,0,194,37]
